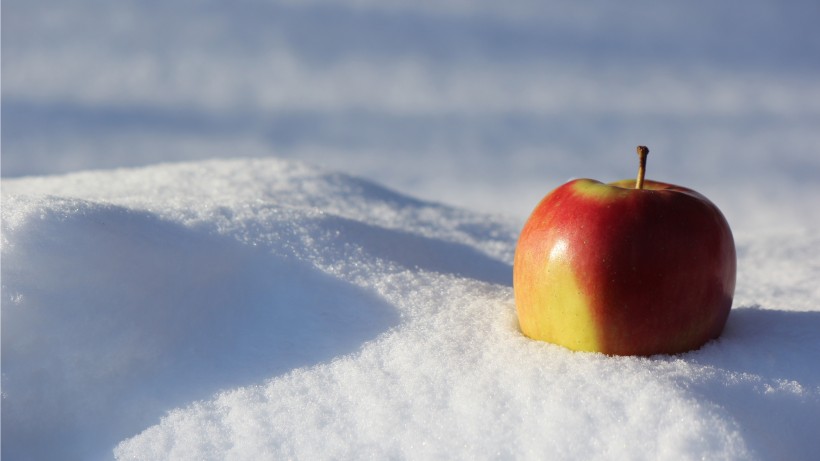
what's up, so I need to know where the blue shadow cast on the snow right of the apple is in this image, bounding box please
[682,306,820,460]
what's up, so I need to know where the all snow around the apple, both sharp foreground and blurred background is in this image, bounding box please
[0,0,820,460]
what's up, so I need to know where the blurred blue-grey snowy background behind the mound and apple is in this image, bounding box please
[2,0,820,227]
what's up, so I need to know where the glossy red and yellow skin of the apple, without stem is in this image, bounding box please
[513,179,737,355]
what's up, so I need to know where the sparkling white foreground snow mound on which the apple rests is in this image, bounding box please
[2,159,820,460]
